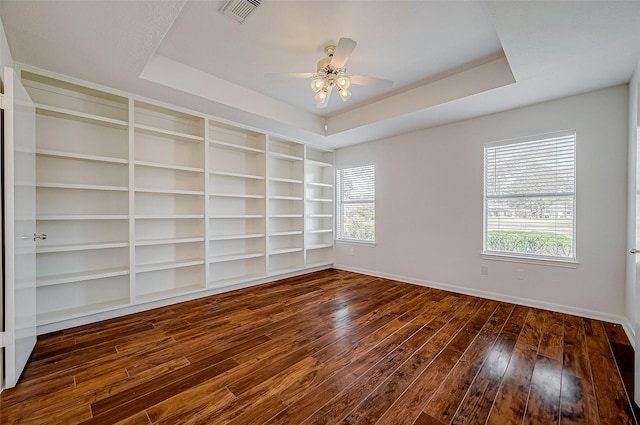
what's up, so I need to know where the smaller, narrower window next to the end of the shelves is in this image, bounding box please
[336,164,376,243]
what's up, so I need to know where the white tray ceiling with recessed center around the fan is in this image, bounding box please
[0,0,640,148]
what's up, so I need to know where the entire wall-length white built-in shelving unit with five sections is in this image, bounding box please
[22,69,333,332]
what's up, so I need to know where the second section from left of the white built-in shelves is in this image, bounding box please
[132,101,206,302]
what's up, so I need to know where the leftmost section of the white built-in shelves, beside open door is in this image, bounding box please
[22,72,132,323]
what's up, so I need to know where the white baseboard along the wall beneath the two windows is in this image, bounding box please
[333,264,635,349]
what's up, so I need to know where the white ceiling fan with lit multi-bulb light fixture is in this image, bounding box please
[265,38,393,108]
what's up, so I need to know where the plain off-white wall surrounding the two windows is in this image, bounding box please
[336,85,628,321]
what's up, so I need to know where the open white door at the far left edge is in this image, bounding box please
[2,68,36,388]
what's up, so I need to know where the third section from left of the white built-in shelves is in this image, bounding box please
[207,123,266,287]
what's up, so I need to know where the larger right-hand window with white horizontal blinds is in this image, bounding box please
[484,131,576,261]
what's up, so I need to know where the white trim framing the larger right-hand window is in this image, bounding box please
[481,129,579,268]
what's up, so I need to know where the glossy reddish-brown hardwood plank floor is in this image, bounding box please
[0,270,635,425]
